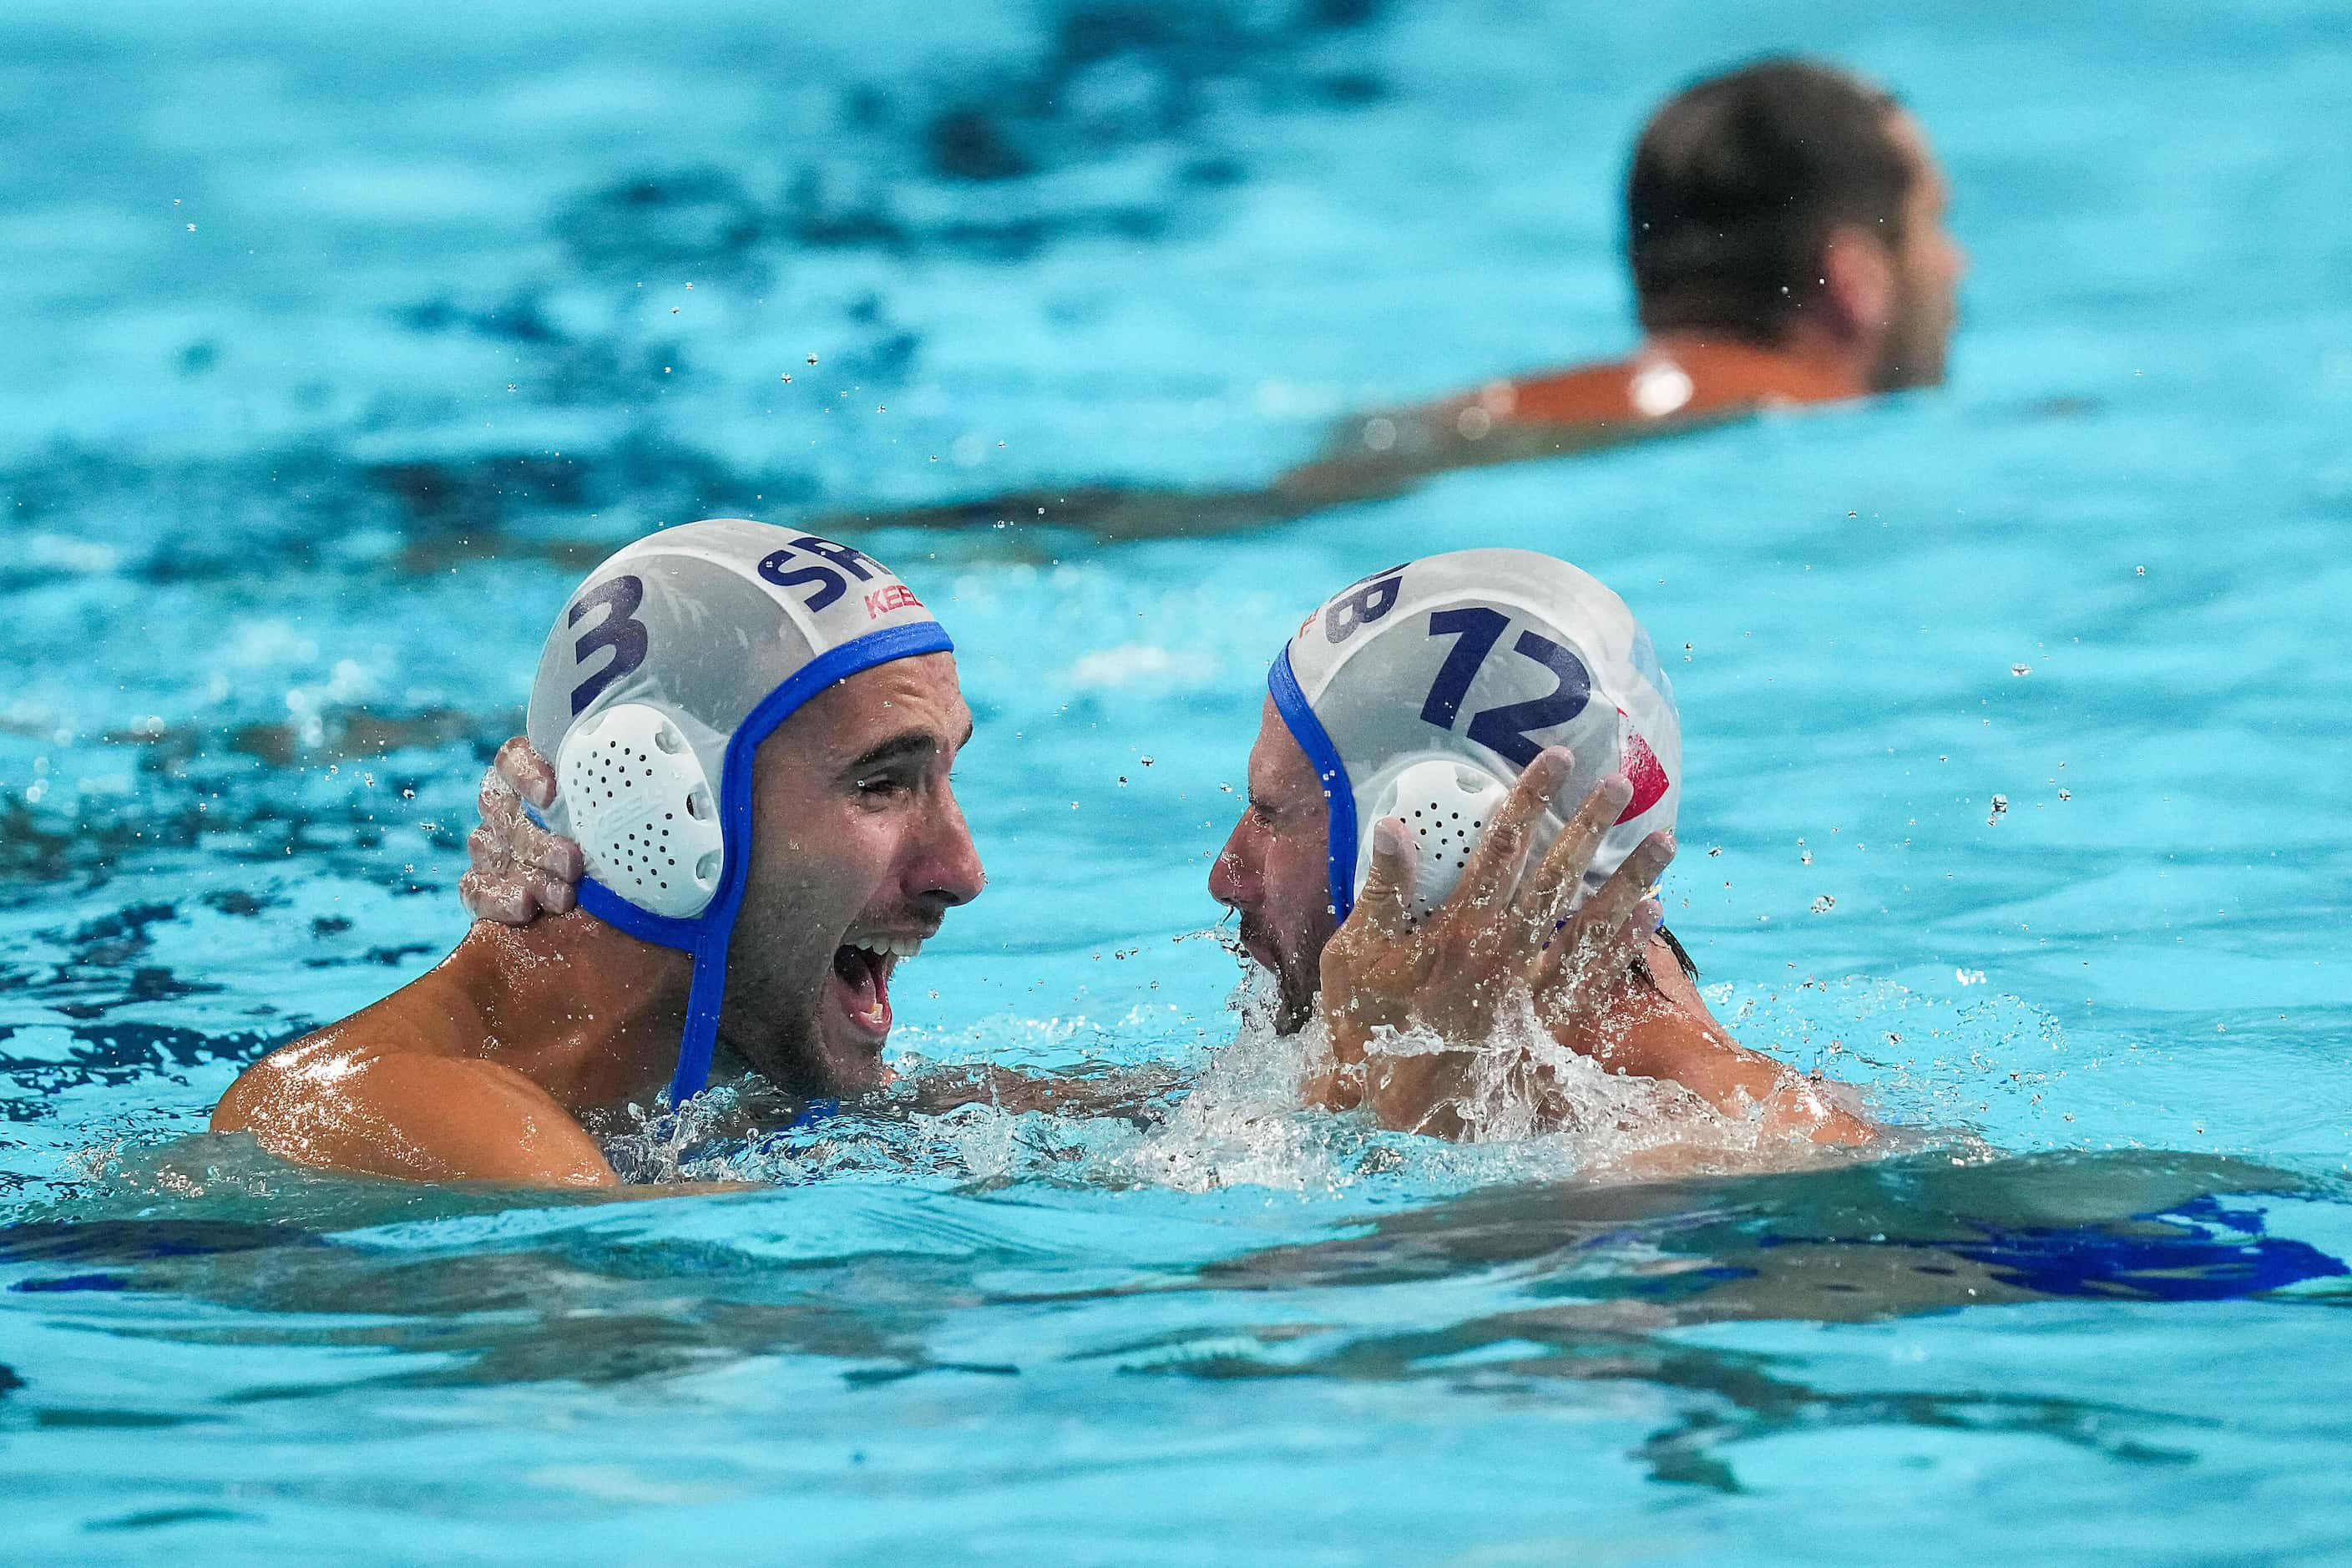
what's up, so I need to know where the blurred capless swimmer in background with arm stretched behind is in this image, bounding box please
[812,58,1966,539]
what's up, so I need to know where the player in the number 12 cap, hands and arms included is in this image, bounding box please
[461,540,1872,1166]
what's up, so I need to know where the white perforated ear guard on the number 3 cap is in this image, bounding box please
[555,703,725,919]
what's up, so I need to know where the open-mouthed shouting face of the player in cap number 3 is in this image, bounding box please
[720,654,984,1093]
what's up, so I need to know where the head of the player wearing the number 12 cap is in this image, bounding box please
[1209,550,1682,1027]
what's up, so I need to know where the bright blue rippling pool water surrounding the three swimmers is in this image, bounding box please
[0,0,2352,1563]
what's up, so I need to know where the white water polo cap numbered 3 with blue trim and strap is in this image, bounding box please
[527,517,955,1105]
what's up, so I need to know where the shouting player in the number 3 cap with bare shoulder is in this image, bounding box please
[212,519,981,1185]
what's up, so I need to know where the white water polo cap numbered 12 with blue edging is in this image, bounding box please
[1266,550,1682,919]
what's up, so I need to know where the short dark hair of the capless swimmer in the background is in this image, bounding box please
[1626,58,1914,343]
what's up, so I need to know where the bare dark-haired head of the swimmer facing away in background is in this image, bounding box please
[1626,58,1966,390]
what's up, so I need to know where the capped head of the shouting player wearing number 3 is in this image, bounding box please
[529,519,981,1100]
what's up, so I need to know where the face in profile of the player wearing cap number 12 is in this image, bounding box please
[1209,698,1338,1032]
